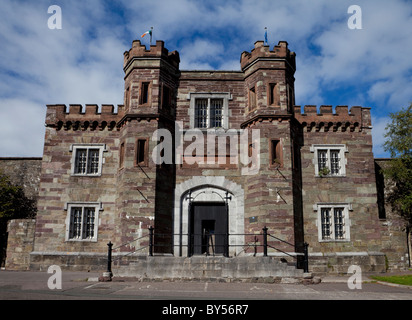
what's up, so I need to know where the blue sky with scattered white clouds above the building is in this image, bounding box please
[0,0,412,157]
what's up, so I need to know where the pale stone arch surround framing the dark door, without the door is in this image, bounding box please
[173,176,245,256]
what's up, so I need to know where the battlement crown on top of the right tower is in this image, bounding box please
[240,41,296,70]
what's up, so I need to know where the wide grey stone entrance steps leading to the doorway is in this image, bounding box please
[112,256,304,280]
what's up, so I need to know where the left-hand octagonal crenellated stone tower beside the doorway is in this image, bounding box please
[117,40,180,252]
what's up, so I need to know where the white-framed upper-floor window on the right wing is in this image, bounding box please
[310,144,348,177]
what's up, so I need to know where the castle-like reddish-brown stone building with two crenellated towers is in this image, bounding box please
[27,40,410,272]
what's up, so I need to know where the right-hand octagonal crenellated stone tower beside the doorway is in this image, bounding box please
[240,41,303,251]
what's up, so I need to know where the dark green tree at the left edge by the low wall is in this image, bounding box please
[0,171,37,265]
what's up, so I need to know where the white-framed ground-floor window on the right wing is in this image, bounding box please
[314,203,352,242]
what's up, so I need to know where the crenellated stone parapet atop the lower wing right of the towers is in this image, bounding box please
[294,105,372,132]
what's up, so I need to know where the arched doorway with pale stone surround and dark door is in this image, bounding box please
[173,176,244,256]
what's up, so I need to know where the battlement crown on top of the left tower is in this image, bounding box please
[123,40,180,68]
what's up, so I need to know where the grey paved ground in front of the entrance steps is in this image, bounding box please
[0,270,412,305]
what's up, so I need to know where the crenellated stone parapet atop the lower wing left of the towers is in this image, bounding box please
[46,104,124,131]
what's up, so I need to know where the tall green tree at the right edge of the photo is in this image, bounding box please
[383,103,412,266]
